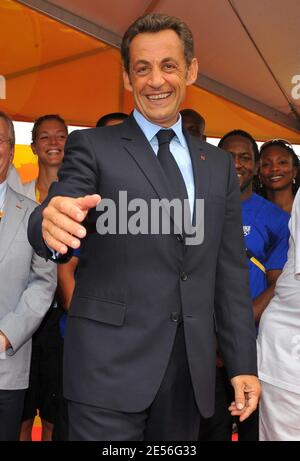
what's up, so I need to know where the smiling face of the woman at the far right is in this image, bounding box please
[260,146,297,191]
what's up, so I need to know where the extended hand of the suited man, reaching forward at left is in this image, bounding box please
[42,194,101,254]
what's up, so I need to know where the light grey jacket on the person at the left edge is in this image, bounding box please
[0,187,56,390]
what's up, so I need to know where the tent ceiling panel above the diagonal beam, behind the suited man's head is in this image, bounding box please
[20,0,300,131]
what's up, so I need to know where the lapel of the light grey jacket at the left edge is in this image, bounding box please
[0,187,27,261]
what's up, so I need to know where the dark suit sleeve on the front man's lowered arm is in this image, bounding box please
[215,156,257,377]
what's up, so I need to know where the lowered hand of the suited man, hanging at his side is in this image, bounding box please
[228,375,260,421]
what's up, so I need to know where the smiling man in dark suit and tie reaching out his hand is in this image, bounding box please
[29,14,260,440]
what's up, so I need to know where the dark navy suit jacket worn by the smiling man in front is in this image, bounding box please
[29,117,256,417]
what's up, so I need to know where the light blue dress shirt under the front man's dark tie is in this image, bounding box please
[133,109,195,213]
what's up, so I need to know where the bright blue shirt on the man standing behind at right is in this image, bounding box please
[242,194,290,299]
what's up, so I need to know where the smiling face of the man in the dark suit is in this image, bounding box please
[124,29,198,127]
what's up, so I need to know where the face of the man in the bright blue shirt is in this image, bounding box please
[222,136,257,200]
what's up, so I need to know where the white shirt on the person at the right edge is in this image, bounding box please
[257,190,300,394]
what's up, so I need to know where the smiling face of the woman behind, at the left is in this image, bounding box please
[31,119,68,167]
